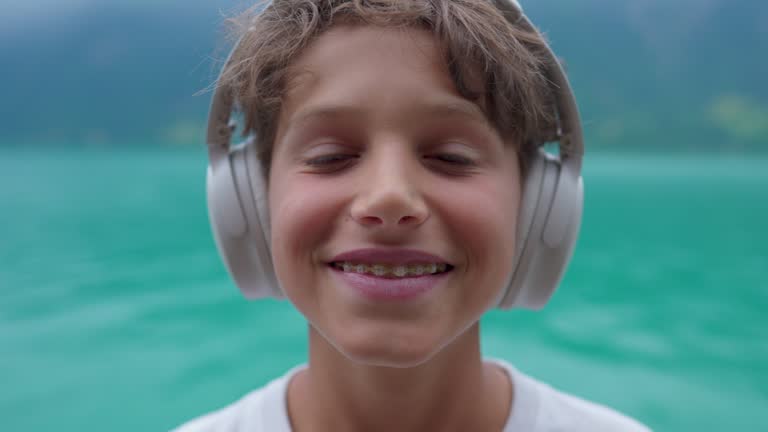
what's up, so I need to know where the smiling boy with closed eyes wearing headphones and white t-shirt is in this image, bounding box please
[179,0,648,432]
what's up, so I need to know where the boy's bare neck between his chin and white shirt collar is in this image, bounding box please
[288,324,512,432]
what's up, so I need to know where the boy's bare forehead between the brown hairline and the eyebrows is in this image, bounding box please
[283,25,487,123]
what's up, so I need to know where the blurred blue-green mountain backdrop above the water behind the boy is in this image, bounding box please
[0,0,768,153]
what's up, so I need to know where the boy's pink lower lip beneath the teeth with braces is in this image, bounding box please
[331,267,450,301]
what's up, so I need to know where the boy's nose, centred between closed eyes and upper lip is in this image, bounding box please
[351,144,429,228]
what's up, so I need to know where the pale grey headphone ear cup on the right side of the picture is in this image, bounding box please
[498,151,583,309]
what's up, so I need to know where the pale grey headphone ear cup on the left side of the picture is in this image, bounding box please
[208,141,283,299]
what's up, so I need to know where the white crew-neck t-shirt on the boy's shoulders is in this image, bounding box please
[174,360,650,432]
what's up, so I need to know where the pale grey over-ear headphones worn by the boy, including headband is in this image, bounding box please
[207,0,584,309]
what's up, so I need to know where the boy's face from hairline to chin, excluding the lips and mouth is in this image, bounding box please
[269,26,520,366]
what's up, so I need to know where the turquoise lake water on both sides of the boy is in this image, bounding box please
[0,149,768,432]
